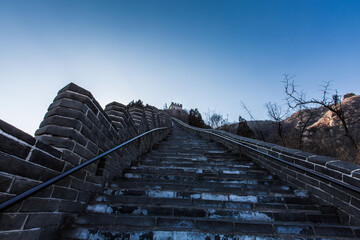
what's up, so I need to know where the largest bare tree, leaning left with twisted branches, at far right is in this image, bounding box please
[284,74,359,151]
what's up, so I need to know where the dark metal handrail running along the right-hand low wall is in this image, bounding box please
[173,118,360,193]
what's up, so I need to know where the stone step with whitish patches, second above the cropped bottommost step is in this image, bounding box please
[86,203,339,224]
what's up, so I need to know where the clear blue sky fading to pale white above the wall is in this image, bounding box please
[0,0,360,134]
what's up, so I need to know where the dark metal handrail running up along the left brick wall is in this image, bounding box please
[0,126,172,211]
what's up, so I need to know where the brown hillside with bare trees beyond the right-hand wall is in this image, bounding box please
[219,94,360,163]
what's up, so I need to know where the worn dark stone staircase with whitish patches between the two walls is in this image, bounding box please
[61,126,360,240]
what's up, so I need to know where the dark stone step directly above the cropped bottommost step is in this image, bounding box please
[63,214,359,239]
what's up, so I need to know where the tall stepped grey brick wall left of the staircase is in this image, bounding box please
[0,83,171,239]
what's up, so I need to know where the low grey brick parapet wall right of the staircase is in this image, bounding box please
[174,119,360,225]
